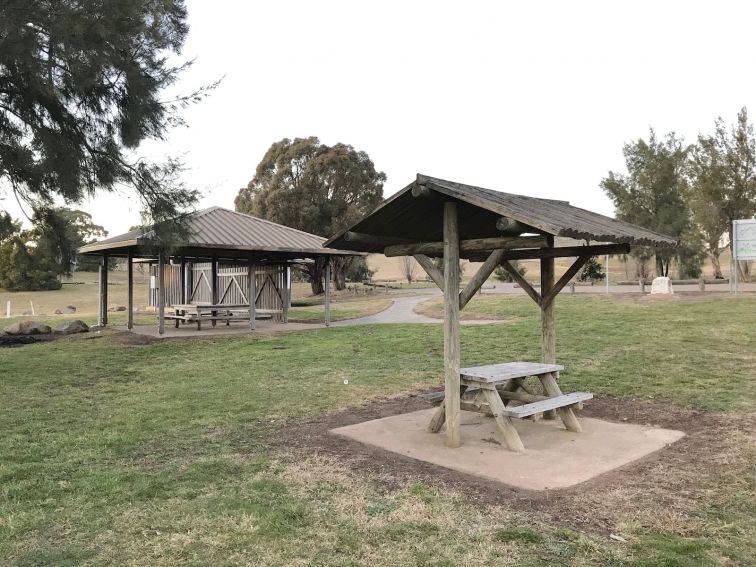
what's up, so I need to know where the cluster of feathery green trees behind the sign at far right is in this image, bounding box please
[601,107,756,278]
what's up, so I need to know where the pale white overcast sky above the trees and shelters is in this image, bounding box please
[5,0,756,235]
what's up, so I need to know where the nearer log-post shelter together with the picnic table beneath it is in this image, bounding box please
[324,174,676,452]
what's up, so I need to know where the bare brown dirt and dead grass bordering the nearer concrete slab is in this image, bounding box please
[272,397,756,534]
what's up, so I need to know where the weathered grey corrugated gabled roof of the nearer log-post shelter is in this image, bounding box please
[324,174,676,252]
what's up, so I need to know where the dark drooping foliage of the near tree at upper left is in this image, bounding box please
[0,0,207,226]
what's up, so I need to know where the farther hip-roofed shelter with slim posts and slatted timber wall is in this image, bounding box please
[79,207,355,335]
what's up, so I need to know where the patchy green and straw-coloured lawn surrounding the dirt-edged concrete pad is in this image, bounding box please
[0,296,756,567]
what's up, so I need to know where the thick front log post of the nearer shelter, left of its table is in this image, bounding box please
[444,202,461,448]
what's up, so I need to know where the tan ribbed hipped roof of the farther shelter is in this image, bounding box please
[79,207,360,257]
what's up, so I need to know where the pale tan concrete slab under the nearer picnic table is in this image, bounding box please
[331,409,685,490]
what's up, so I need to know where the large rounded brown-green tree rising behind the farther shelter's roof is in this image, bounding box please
[234,136,386,293]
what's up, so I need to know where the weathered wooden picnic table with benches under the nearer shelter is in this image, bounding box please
[428,361,593,451]
